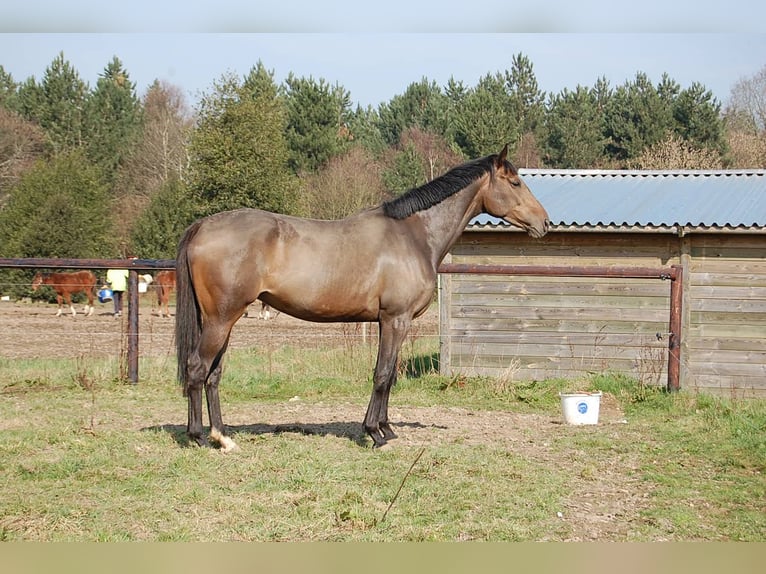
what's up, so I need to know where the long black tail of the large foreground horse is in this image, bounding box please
[176,221,202,396]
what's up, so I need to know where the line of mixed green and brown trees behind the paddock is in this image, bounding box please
[0,53,766,290]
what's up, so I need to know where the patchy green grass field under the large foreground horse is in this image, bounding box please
[0,344,766,541]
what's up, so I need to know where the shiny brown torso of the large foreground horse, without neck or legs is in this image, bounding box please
[186,209,435,321]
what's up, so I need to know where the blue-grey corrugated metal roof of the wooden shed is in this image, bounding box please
[469,169,766,230]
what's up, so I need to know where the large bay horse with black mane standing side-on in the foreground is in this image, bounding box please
[175,145,550,452]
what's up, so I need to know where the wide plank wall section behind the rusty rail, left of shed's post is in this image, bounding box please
[441,232,680,385]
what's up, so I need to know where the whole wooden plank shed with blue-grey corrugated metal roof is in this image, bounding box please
[439,170,766,396]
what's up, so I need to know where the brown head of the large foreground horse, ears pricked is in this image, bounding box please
[481,145,551,238]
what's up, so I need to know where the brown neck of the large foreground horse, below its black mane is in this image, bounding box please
[417,181,481,268]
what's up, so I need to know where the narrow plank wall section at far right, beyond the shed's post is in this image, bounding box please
[684,234,766,396]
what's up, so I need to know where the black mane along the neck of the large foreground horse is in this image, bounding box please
[383,155,497,219]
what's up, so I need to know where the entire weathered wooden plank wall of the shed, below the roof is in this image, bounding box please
[440,231,766,396]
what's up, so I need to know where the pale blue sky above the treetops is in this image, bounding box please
[0,0,766,106]
